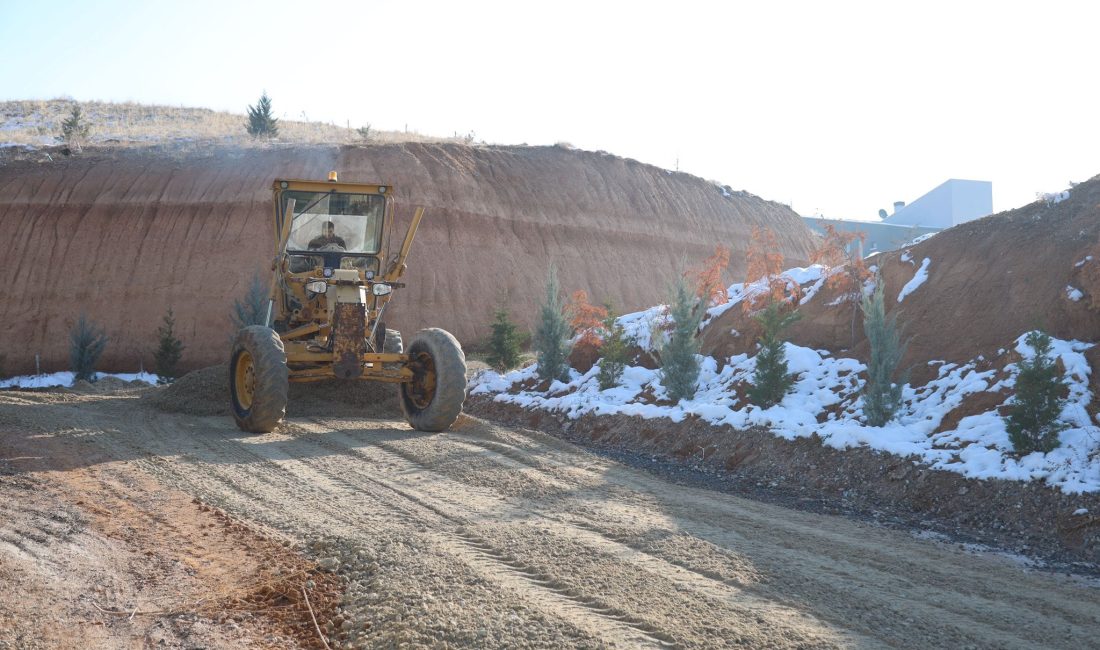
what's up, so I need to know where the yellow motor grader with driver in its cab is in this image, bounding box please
[229,172,466,433]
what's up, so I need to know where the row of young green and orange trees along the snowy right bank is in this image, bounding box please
[487,224,1066,455]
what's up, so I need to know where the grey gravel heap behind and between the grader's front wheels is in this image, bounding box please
[145,365,402,418]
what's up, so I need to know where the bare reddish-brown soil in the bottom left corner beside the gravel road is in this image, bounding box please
[0,394,343,649]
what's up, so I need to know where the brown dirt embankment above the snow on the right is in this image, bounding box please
[703,177,1100,383]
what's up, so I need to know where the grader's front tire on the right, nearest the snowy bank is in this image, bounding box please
[400,328,466,431]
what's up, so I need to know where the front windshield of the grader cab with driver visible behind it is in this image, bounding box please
[283,191,386,254]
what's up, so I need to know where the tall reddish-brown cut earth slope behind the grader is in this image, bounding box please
[0,144,814,373]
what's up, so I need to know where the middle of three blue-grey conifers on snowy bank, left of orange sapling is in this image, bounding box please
[661,277,706,401]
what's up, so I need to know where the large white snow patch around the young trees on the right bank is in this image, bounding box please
[471,334,1100,494]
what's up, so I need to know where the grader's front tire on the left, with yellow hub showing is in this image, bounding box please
[229,326,290,433]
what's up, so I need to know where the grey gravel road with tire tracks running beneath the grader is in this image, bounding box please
[0,393,1100,648]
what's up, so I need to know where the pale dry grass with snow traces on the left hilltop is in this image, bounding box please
[0,99,472,146]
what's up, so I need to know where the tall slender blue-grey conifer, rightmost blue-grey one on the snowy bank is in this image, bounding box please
[861,278,909,427]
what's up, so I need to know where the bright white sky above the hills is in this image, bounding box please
[0,0,1100,218]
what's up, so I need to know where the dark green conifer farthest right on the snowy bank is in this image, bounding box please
[1004,330,1066,455]
